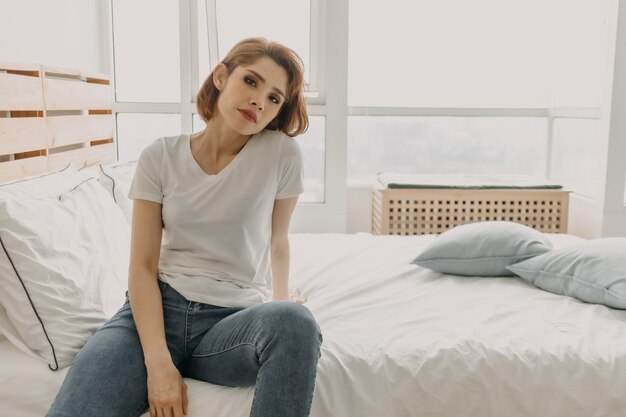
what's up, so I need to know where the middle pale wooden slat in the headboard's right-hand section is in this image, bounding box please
[46,115,113,148]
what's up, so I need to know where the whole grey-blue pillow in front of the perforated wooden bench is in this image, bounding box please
[411,221,552,277]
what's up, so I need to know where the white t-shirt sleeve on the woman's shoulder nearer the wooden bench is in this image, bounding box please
[275,138,304,200]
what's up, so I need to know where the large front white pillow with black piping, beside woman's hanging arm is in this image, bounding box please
[0,179,130,370]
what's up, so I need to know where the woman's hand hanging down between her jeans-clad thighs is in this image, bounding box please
[148,360,188,417]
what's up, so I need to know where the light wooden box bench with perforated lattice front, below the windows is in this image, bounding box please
[372,188,569,235]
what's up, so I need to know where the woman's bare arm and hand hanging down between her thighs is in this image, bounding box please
[128,200,187,417]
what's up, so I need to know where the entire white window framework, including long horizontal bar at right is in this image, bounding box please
[102,0,602,233]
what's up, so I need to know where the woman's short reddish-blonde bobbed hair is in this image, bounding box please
[196,38,309,137]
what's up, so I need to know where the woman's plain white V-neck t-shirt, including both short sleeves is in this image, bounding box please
[128,130,303,307]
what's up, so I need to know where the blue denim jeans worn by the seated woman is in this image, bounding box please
[46,281,322,417]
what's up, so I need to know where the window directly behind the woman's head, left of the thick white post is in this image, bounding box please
[111,0,326,203]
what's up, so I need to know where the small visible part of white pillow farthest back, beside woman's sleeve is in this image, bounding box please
[98,161,137,224]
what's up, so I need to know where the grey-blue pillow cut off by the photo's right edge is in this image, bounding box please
[509,238,626,309]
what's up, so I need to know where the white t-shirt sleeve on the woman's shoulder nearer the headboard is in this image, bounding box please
[128,140,163,204]
